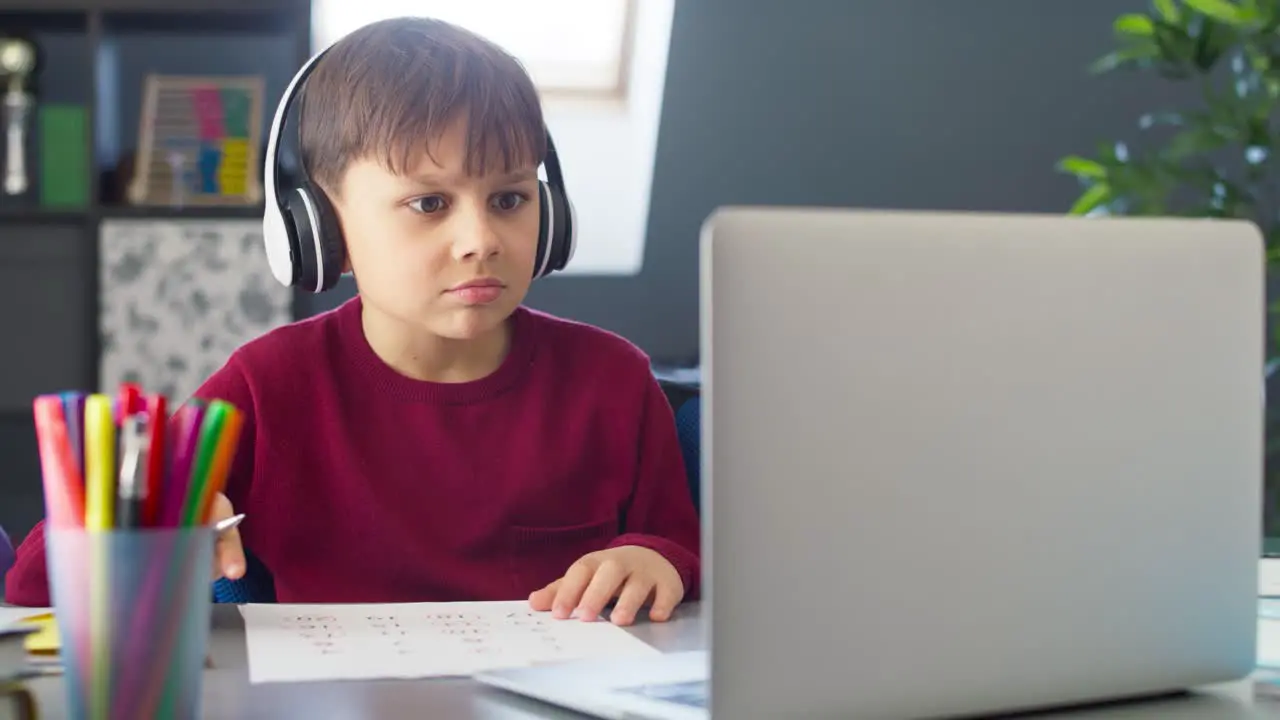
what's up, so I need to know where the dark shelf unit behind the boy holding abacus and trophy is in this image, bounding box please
[0,0,311,539]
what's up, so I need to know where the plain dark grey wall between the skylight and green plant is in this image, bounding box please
[306,0,1185,361]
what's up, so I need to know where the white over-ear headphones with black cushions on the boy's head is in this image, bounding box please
[262,40,577,292]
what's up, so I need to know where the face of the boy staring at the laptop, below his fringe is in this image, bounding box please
[333,118,539,340]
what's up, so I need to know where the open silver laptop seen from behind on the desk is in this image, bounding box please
[476,208,1265,717]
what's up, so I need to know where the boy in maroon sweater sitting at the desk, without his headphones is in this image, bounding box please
[8,18,700,624]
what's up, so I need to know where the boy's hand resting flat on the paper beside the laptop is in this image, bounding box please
[529,546,685,625]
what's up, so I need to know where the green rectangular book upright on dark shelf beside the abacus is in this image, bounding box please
[37,104,91,210]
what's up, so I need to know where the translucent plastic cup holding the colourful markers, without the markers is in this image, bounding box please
[45,525,216,720]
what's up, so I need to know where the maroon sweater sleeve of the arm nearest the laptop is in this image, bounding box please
[609,374,701,601]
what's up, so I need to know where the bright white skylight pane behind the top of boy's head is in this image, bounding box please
[312,0,636,97]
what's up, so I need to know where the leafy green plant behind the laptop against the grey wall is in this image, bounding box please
[1057,0,1280,536]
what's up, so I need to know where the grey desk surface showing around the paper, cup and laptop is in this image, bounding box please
[15,603,1280,720]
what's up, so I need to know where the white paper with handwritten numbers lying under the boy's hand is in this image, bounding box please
[241,601,658,683]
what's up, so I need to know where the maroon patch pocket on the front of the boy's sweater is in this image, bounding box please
[508,518,618,597]
